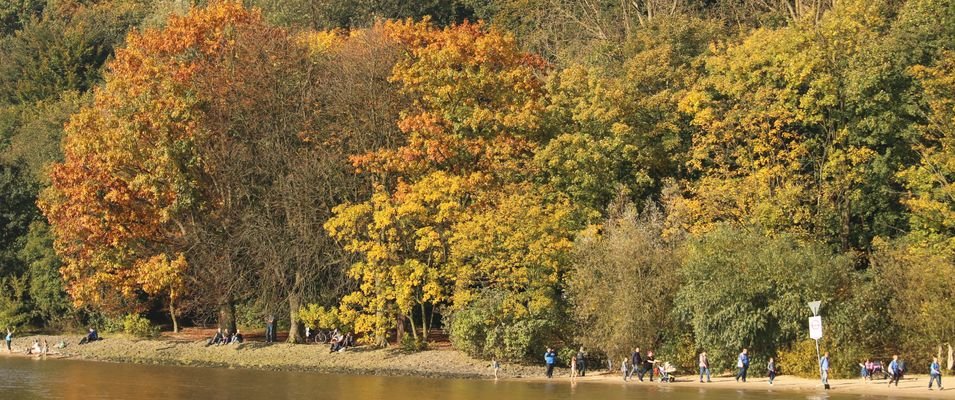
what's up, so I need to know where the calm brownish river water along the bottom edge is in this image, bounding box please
[0,357,920,400]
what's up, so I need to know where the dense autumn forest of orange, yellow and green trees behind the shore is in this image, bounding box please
[0,0,955,374]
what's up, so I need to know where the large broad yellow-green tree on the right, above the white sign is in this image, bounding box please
[672,2,917,250]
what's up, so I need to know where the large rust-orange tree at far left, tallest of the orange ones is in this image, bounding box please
[42,2,318,329]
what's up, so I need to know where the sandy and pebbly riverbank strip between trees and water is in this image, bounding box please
[0,336,955,399]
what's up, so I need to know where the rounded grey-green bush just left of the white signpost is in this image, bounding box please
[675,226,851,369]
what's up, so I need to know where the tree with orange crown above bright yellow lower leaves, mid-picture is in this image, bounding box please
[326,22,567,348]
